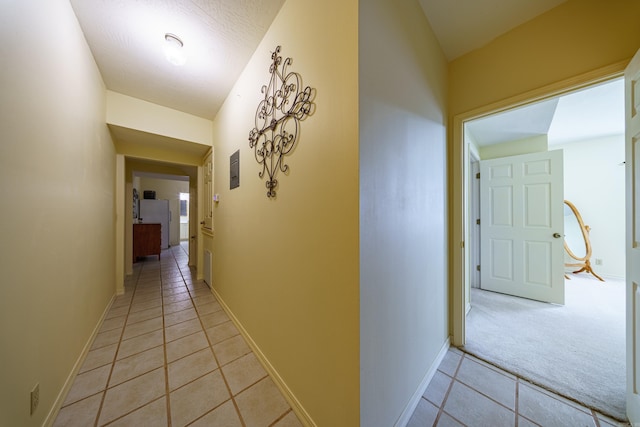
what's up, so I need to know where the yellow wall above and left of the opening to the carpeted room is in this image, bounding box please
[448,0,640,344]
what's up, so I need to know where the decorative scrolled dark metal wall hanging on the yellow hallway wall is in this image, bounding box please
[249,46,315,197]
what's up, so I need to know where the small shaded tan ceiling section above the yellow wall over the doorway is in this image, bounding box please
[419,0,566,61]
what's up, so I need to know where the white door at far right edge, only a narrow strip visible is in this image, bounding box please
[624,47,640,425]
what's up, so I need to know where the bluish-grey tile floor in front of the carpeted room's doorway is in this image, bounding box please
[408,348,627,427]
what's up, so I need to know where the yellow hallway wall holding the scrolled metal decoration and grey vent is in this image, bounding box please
[208,0,359,426]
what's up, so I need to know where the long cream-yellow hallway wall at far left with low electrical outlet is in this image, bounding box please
[0,0,116,426]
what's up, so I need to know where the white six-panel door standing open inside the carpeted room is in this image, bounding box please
[480,150,564,304]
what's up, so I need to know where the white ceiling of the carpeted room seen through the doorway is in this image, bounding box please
[466,79,624,146]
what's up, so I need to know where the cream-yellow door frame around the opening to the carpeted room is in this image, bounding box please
[449,61,628,346]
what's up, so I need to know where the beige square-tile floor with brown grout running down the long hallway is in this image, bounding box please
[54,246,301,427]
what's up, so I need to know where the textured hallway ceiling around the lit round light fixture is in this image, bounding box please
[71,0,284,119]
